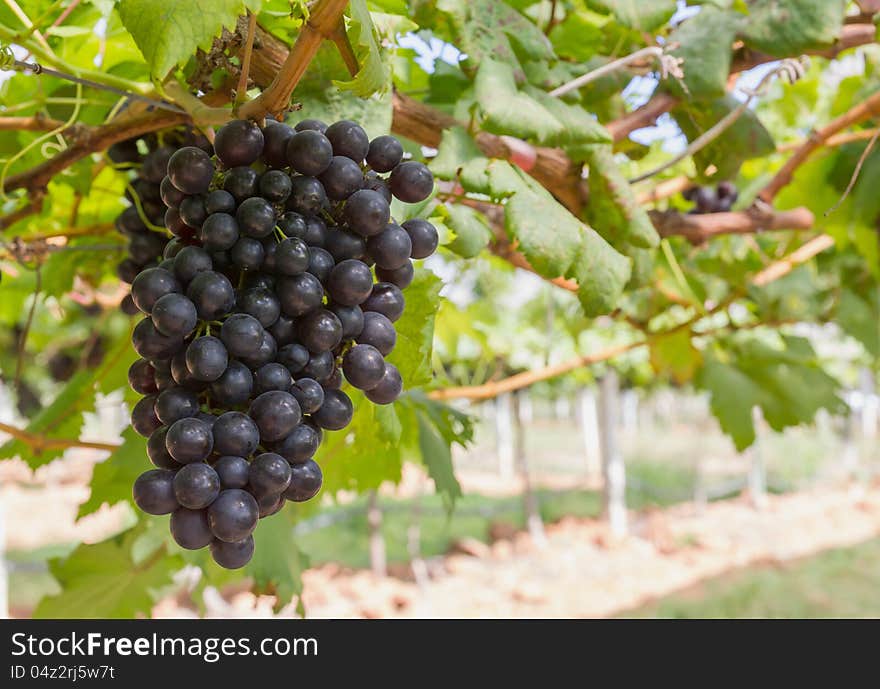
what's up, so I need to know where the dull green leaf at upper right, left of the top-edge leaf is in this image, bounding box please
[666,7,742,100]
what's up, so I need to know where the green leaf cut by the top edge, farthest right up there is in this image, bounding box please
[741,0,848,57]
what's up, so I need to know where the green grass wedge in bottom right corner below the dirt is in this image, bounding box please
[621,539,880,619]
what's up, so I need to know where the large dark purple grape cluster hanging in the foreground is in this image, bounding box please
[129,120,438,569]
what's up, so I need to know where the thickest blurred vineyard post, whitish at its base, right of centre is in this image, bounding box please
[599,369,628,536]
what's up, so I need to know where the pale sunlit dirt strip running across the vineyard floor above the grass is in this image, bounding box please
[154,478,880,618]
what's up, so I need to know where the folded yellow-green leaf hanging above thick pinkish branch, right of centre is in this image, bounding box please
[587,146,660,249]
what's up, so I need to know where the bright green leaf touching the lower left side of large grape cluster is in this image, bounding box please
[76,428,144,519]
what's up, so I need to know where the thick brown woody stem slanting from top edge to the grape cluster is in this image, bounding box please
[238,0,348,120]
